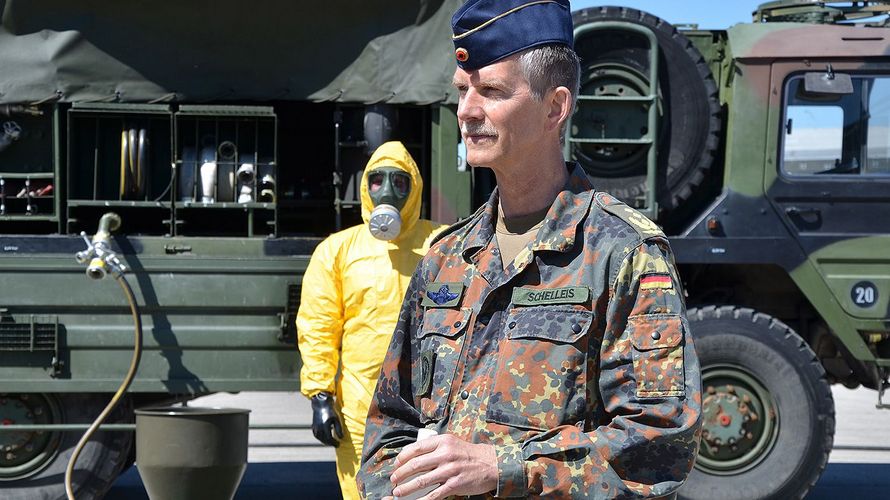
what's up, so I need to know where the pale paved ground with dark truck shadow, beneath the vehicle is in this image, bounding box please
[106,387,890,500]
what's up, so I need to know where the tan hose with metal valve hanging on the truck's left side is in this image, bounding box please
[65,212,142,500]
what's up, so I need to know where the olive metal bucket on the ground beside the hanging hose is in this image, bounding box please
[136,407,250,500]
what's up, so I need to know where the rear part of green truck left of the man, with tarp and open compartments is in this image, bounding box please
[0,0,472,500]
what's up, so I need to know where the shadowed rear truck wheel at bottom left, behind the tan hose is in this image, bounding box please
[0,394,133,500]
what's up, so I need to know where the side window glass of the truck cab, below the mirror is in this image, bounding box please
[781,76,890,177]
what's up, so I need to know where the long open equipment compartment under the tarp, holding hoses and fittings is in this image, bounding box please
[0,101,432,238]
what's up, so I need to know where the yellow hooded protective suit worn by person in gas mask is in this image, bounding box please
[297,142,445,499]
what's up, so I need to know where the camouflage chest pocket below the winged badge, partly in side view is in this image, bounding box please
[411,308,471,424]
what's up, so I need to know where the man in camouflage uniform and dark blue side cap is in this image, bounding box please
[358,0,701,499]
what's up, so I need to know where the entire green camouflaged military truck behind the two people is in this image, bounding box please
[0,0,890,499]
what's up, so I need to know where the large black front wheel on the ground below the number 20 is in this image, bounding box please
[679,306,834,500]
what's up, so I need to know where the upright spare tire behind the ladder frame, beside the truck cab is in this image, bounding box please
[569,7,721,210]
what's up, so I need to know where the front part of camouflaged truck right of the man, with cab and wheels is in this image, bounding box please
[566,0,890,499]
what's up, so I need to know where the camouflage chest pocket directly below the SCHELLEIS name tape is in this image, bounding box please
[486,306,593,430]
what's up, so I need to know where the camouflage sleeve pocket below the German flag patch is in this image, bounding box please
[627,314,685,398]
